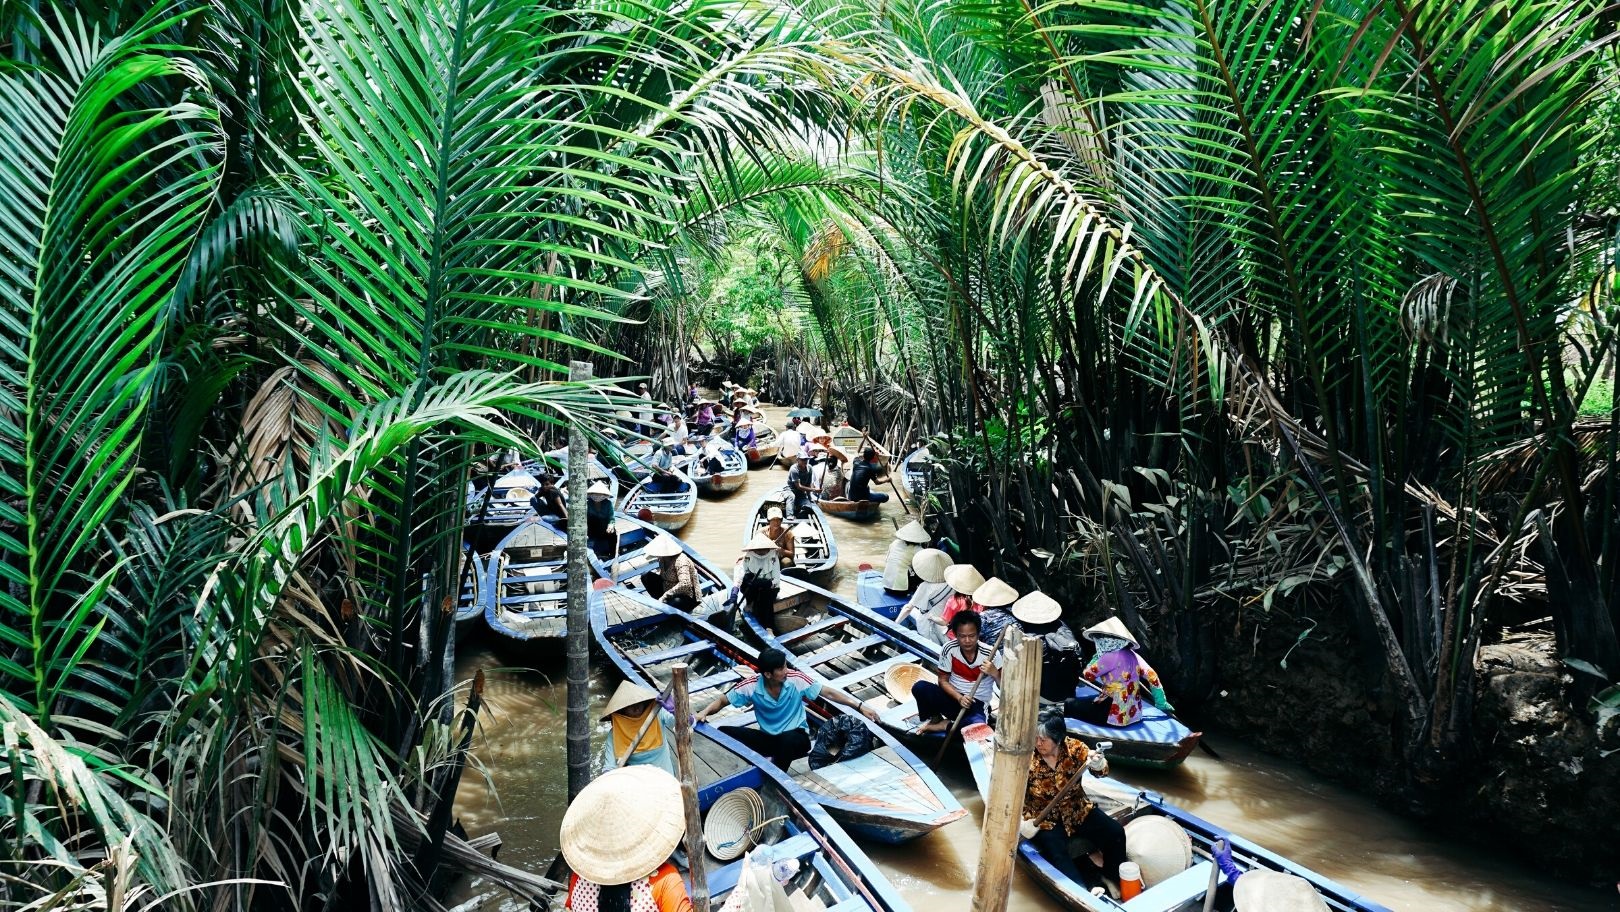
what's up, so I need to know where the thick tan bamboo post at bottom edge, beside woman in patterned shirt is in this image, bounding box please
[974,635,1040,912]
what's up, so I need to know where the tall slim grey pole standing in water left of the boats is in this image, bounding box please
[567,361,591,803]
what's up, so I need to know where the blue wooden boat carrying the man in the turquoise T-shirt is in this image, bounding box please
[591,586,967,844]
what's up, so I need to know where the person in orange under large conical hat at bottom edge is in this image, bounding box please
[561,765,692,912]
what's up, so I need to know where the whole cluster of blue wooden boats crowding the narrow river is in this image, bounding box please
[457,414,1383,912]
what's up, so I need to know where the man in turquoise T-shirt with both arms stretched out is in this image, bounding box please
[697,648,878,769]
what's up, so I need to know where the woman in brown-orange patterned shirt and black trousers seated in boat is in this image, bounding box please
[1019,711,1129,888]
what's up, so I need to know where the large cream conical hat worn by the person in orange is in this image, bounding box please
[562,765,687,886]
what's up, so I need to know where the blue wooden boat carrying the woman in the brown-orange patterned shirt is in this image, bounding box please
[962,726,1388,912]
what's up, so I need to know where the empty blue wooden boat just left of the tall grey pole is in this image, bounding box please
[484,518,569,658]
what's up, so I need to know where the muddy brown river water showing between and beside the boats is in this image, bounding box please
[454,408,1620,912]
